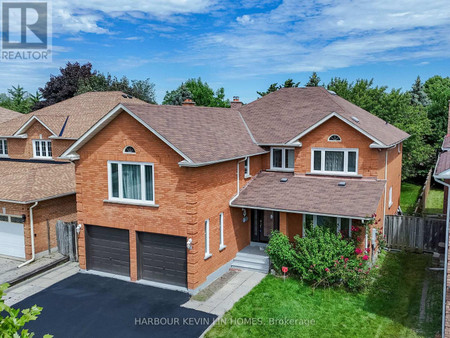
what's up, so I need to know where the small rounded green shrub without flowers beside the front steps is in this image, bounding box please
[266,231,295,272]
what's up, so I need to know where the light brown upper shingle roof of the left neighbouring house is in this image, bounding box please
[0,91,145,139]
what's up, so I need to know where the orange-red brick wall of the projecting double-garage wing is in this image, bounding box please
[76,113,250,289]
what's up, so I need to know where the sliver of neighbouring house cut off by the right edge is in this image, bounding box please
[434,105,450,337]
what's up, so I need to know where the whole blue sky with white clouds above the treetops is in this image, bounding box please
[0,0,450,102]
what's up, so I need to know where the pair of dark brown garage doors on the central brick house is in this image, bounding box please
[85,225,187,287]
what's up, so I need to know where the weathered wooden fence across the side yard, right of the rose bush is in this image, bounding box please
[384,216,445,252]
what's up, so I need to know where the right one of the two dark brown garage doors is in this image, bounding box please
[137,232,187,287]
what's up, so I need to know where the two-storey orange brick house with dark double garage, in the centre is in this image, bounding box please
[61,87,408,292]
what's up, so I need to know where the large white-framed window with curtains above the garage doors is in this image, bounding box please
[108,161,155,204]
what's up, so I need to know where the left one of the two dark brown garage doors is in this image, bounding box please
[85,225,130,276]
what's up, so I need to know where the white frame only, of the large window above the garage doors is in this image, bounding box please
[108,161,155,205]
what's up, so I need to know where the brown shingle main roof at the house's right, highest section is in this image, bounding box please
[240,87,409,145]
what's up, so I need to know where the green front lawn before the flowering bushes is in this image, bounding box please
[207,253,442,337]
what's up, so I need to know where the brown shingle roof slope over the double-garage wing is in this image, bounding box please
[124,103,265,163]
